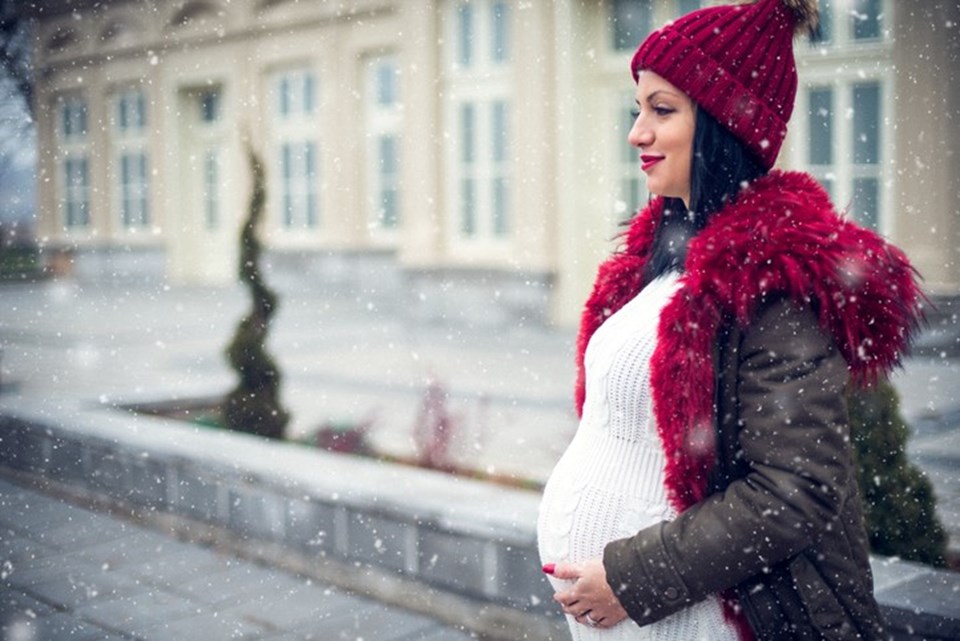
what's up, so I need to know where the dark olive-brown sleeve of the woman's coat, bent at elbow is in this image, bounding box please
[603,300,856,625]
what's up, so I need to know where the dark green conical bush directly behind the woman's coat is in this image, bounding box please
[849,380,947,567]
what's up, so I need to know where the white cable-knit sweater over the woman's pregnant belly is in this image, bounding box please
[537,273,737,641]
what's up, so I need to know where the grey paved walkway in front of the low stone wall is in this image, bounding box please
[0,479,472,641]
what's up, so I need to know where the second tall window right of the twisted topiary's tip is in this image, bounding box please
[366,56,402,231]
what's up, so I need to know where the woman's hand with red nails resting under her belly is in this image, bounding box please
[552,559,627,628]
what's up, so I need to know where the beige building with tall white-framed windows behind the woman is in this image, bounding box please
[24,0,960,324]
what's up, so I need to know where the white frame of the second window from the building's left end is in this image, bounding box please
[110,85,152,235]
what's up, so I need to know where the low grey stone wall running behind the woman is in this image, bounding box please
[0,402,960,640]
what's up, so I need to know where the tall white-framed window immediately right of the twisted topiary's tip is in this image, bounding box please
[268,66,320,231]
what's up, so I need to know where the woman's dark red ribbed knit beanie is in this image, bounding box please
[630,0,817,169]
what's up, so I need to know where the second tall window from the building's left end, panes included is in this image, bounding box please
[111,87,150,231]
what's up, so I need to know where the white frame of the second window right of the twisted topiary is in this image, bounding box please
[364,53,403,242]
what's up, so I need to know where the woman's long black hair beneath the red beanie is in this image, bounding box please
[643,109,766,283]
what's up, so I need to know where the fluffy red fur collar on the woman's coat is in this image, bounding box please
[576,171,922,511]
